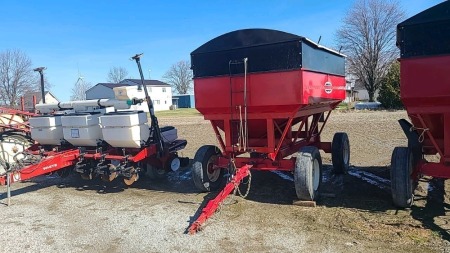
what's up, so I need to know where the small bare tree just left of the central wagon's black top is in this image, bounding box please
[163,61,193,94]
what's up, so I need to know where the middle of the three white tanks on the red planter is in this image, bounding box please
[61,112,103,146]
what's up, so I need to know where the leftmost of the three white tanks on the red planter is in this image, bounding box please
[29,115,64,145]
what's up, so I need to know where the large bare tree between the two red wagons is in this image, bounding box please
[337,0,405,101]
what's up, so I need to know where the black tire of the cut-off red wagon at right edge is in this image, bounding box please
[391,147,414,208]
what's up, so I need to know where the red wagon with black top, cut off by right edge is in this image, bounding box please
[391,1,450,207]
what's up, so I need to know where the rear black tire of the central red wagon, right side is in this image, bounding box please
[331,133,350,174]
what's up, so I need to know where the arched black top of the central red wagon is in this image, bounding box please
[191,29,345,77]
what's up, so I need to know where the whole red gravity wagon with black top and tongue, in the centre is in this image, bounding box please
[190,29,350,233]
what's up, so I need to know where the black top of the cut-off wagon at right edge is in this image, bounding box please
[397,1,450,58]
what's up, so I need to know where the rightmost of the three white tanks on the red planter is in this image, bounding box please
[100,111,150,148]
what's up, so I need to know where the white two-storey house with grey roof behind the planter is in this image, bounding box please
[86,79,172,112]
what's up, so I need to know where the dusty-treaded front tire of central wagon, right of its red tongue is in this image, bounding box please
[294,146,322,201]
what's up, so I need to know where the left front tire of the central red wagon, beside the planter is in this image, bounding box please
[191,145,224,191]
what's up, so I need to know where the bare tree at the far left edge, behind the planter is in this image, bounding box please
[0,50,37,106]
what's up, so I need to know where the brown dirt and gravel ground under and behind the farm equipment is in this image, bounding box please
[0,111,450,253]
